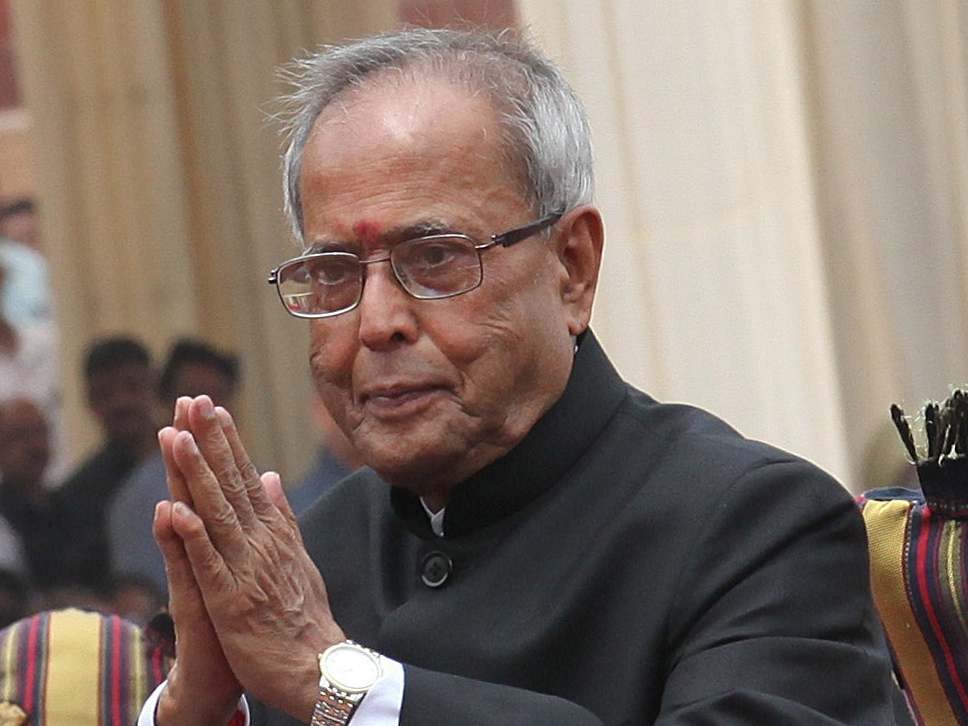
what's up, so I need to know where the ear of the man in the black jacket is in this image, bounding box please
[555,204,605,336]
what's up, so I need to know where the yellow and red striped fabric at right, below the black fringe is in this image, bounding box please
[859,489,968,726]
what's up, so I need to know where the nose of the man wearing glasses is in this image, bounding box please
[359,261,418,350]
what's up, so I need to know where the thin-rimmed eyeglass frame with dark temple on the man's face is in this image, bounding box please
[267,212,564,320]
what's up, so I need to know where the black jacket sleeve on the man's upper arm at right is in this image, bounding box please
[656,461,896,726]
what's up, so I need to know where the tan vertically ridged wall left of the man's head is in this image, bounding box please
[14,0,396,484]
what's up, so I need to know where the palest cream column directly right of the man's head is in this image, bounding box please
[519,0,850,490]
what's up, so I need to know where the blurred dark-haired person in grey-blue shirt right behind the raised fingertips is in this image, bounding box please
[108,338,239,592]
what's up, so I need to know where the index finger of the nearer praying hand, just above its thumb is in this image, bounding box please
[171,431,247,565]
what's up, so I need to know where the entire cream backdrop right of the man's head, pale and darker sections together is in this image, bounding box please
[519,0,968,490]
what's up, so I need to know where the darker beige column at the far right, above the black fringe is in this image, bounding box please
[804,0,968,486]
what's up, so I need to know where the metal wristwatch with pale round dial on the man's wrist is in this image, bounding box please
[310,640,383,726]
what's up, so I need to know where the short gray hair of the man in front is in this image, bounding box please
[272,28,594,240]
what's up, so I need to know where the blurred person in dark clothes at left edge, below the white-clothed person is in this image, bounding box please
[0,398,59,590]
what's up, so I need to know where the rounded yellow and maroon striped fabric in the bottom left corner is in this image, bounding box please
[0,609,171,726]
